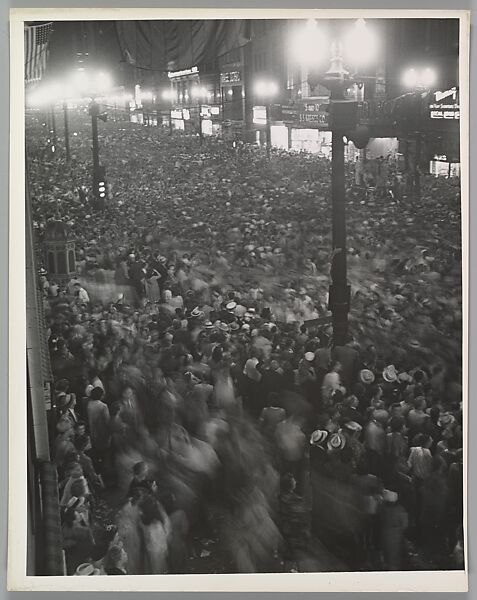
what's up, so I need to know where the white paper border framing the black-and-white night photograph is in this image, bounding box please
[7,8,470,592]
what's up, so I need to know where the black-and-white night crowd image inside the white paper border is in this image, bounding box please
[16,11,468,591]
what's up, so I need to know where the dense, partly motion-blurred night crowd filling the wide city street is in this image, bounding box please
[27,109,463,575]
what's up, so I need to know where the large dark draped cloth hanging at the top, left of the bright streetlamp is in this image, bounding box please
[116,19,252,72]
